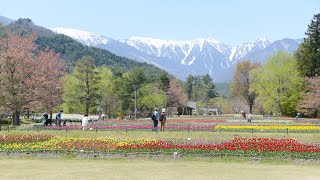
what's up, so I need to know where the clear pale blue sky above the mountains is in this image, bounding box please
[0,0,320,45]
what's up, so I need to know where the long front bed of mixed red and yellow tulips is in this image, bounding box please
[0,135,320,158]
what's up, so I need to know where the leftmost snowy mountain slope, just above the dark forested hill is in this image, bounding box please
[49,27,109,46]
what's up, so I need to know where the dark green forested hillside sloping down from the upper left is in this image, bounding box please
[2,19,162,79]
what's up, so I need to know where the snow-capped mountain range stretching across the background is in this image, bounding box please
[51,28,301,82]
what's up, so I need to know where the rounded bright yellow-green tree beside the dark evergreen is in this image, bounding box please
[250,52,303,115]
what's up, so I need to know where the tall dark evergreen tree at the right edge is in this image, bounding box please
[295,13,320,77]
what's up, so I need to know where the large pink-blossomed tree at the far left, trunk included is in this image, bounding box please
[0,32,63,125]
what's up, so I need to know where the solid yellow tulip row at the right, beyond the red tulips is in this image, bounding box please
[215,125,320,131]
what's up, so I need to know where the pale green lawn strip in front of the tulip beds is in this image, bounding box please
[0,157,320,180]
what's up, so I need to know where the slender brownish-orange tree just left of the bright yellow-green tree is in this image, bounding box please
[231,61,260,113]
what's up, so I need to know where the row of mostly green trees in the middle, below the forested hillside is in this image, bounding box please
[63,56,186,116]
